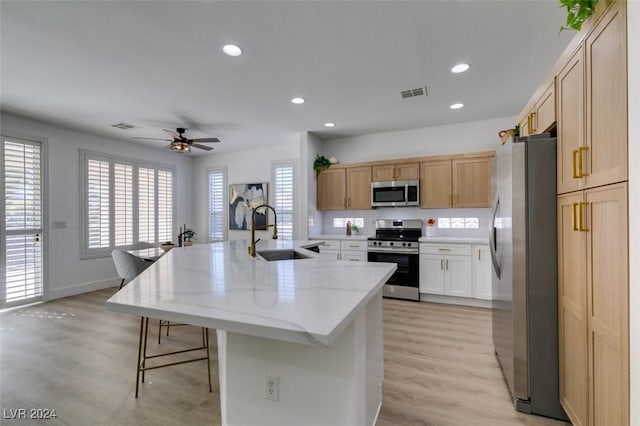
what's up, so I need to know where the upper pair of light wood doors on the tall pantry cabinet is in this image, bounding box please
[558,2,628,194]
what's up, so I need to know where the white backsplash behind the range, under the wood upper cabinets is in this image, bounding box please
[316,207,491,238]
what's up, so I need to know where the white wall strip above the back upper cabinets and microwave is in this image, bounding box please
[322,117,516,163]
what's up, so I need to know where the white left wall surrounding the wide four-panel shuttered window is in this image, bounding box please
[1,113,193,299]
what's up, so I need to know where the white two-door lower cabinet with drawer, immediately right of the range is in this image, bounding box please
[420,243,473,297]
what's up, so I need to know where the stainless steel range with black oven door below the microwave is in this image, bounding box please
[367,219,422,300]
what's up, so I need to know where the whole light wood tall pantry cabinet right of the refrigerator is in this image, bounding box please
[557,1,629,426]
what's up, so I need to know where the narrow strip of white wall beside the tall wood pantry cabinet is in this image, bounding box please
[627,0,640,426]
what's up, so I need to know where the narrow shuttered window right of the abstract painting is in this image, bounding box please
[272,161,295,240]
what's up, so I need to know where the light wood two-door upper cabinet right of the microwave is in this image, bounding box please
[420,157,491,209]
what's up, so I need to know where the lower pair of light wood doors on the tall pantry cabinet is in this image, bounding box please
[558,183,629,426]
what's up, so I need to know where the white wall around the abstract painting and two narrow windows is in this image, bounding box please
[191,135,300,241]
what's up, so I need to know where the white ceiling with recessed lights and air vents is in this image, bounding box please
[0,0,573,155]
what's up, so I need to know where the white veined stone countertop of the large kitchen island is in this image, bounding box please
[106,240,397,347]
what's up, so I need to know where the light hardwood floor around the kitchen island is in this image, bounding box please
[0,289,564,426]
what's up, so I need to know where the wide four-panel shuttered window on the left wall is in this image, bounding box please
[81,151,175,257]
